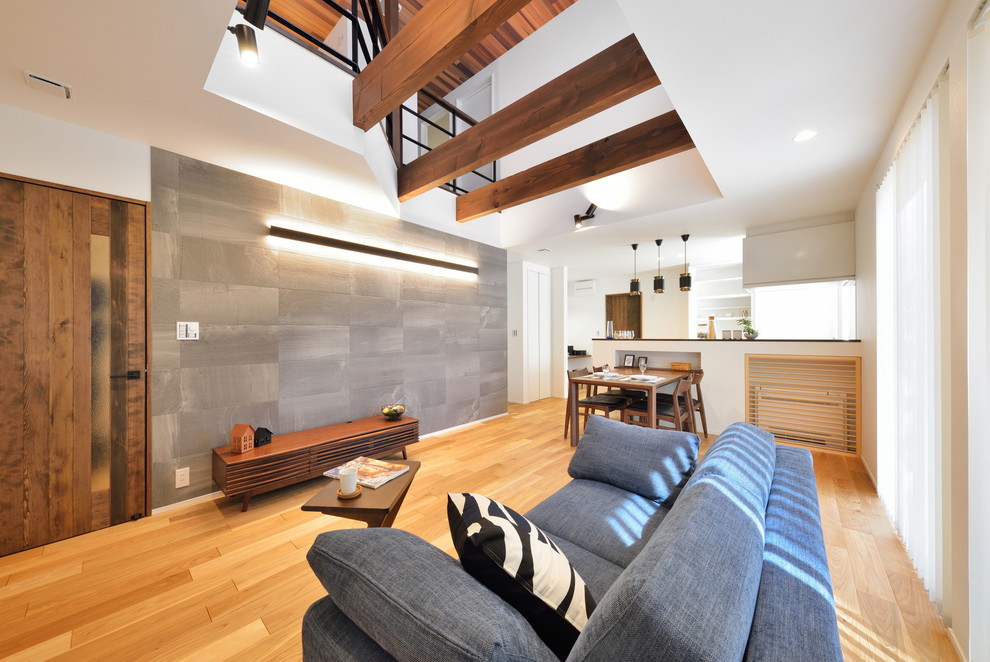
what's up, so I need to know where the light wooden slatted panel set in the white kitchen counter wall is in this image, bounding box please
[746,354,861,453]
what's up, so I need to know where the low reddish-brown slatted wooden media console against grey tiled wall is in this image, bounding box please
[213,416,419,511]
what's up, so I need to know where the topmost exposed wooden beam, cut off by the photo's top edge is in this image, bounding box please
[354,0,529,131]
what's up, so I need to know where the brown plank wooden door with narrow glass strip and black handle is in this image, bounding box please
[0,177,149,555]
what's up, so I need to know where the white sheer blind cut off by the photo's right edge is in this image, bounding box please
[966,10,990,661]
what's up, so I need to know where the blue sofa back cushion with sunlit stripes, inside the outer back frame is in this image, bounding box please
[567,423,776,662]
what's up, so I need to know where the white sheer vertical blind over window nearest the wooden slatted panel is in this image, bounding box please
[877,83,944,603]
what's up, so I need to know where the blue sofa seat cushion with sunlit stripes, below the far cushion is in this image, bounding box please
[526,480,669,568]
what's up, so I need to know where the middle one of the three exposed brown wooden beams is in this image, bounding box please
[399,35,660,202]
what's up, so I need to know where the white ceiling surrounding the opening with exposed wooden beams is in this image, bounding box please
[0,0,949,278]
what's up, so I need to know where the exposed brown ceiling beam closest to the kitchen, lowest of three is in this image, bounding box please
[457,110,694,223]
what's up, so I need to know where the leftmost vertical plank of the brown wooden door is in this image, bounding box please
[0,179,25,554]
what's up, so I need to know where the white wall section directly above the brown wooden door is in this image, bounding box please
[0,102,151,200]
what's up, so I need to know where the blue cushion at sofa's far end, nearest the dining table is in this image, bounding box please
[567,416,700,506]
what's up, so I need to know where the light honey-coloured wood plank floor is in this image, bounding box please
[0,400,957,662]
